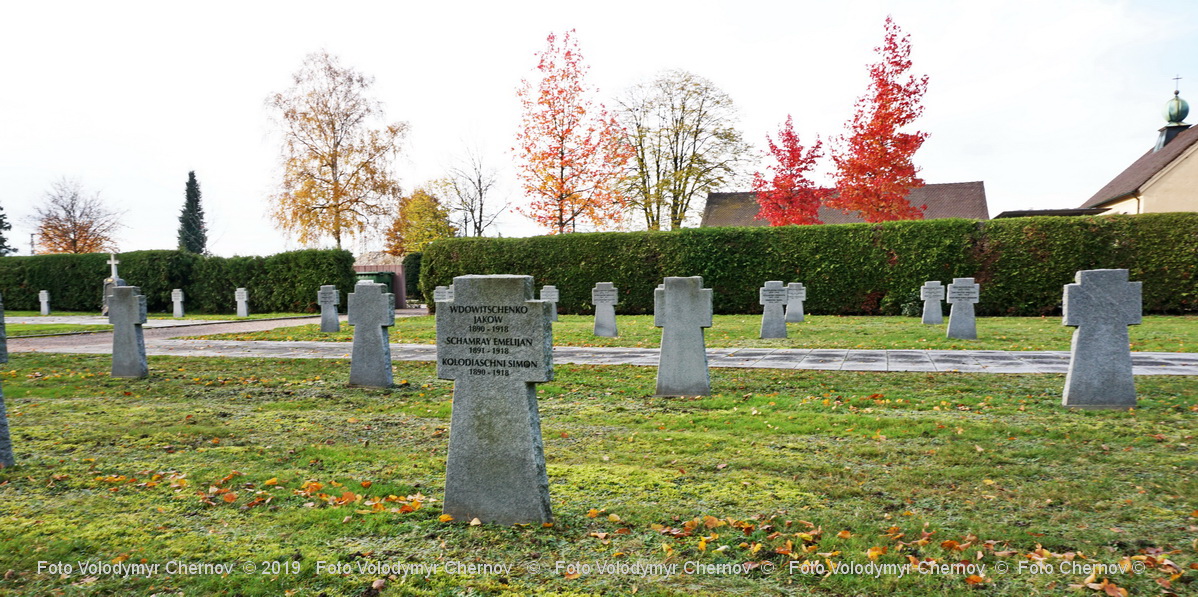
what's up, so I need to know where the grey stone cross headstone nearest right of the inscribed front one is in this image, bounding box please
[653,276,712,396]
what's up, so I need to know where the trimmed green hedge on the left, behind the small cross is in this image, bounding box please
[0,251,355,313]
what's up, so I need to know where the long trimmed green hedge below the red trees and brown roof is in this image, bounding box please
[419,213,1198,315]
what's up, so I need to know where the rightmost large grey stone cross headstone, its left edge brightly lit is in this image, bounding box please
[1061,270,1142,409]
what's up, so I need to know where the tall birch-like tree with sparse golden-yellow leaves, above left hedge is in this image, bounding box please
[267,52,407,248]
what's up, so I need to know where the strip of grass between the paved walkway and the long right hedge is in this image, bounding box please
[189,315,1198,352]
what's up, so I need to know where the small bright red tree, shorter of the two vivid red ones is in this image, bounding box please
[752,115,829,225]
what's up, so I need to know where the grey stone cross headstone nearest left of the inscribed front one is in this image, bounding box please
[347,281,395,387]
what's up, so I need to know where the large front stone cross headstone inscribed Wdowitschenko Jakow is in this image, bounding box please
[437,276,553,525]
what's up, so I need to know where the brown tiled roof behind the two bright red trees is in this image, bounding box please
[700,181,990,228]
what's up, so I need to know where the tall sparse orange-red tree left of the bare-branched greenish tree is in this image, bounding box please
[514,30,630,234]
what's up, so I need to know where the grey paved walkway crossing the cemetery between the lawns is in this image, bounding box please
[8,313,1198,375]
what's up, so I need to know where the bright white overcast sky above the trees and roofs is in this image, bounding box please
[0,0,1198,255]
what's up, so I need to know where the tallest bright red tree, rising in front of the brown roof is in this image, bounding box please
[825,17,927,222]
